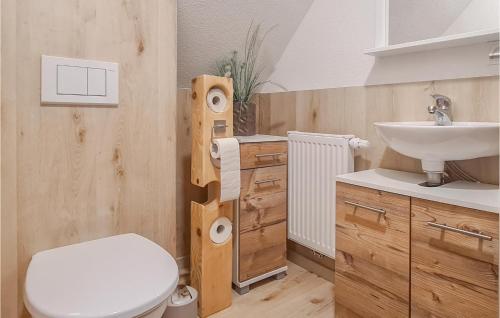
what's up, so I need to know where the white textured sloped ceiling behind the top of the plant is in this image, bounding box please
[177,0,313,88]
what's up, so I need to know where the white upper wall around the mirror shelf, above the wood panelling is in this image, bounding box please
[263,0,499,92]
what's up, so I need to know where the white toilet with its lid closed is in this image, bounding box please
[24,234,179,318]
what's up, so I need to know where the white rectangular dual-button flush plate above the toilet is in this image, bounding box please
[41,55,118,106]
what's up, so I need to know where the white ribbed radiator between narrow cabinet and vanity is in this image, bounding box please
[288,131,367,258]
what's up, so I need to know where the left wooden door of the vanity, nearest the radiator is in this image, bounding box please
[335,182,410,318]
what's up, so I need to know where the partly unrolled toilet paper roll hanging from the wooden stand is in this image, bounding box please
[210,138,241,202]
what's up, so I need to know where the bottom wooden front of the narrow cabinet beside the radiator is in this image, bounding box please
[239,222,286,282]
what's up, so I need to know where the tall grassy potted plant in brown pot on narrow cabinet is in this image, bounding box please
[216,24,279,136]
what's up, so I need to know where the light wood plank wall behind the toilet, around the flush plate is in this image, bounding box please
[1,0,177,318]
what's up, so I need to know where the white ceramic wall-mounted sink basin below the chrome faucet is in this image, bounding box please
[375,121,500,172]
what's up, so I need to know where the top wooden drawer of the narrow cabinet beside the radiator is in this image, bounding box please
[240,141,288,169]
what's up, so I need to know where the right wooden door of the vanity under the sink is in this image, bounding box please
[411,198,498,318]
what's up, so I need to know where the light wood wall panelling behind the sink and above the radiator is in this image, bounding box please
[258,76,499,184]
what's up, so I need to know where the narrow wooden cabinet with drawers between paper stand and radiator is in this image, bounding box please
[233,141,287,293]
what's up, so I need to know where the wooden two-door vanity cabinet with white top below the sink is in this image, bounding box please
[335,169,500,318]
